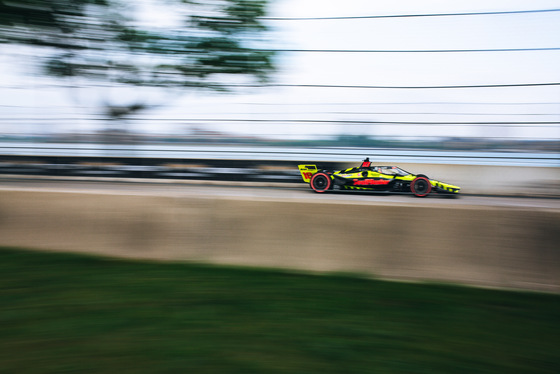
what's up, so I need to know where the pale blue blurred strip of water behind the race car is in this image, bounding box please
[0,143,560,167]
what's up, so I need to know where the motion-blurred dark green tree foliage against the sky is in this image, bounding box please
[0,0,274,134]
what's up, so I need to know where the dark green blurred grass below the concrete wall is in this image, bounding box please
[0,248,560,374]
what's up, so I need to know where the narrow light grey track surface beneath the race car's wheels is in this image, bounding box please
[0,177,560,210]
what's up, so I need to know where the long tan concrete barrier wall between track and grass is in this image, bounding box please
[0,191,560,292]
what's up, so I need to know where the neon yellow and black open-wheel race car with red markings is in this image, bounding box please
[298,158,461,197]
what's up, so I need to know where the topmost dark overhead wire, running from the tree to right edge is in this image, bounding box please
[261,9,560,21]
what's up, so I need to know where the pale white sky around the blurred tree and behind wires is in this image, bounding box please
[0,0,560,140]
